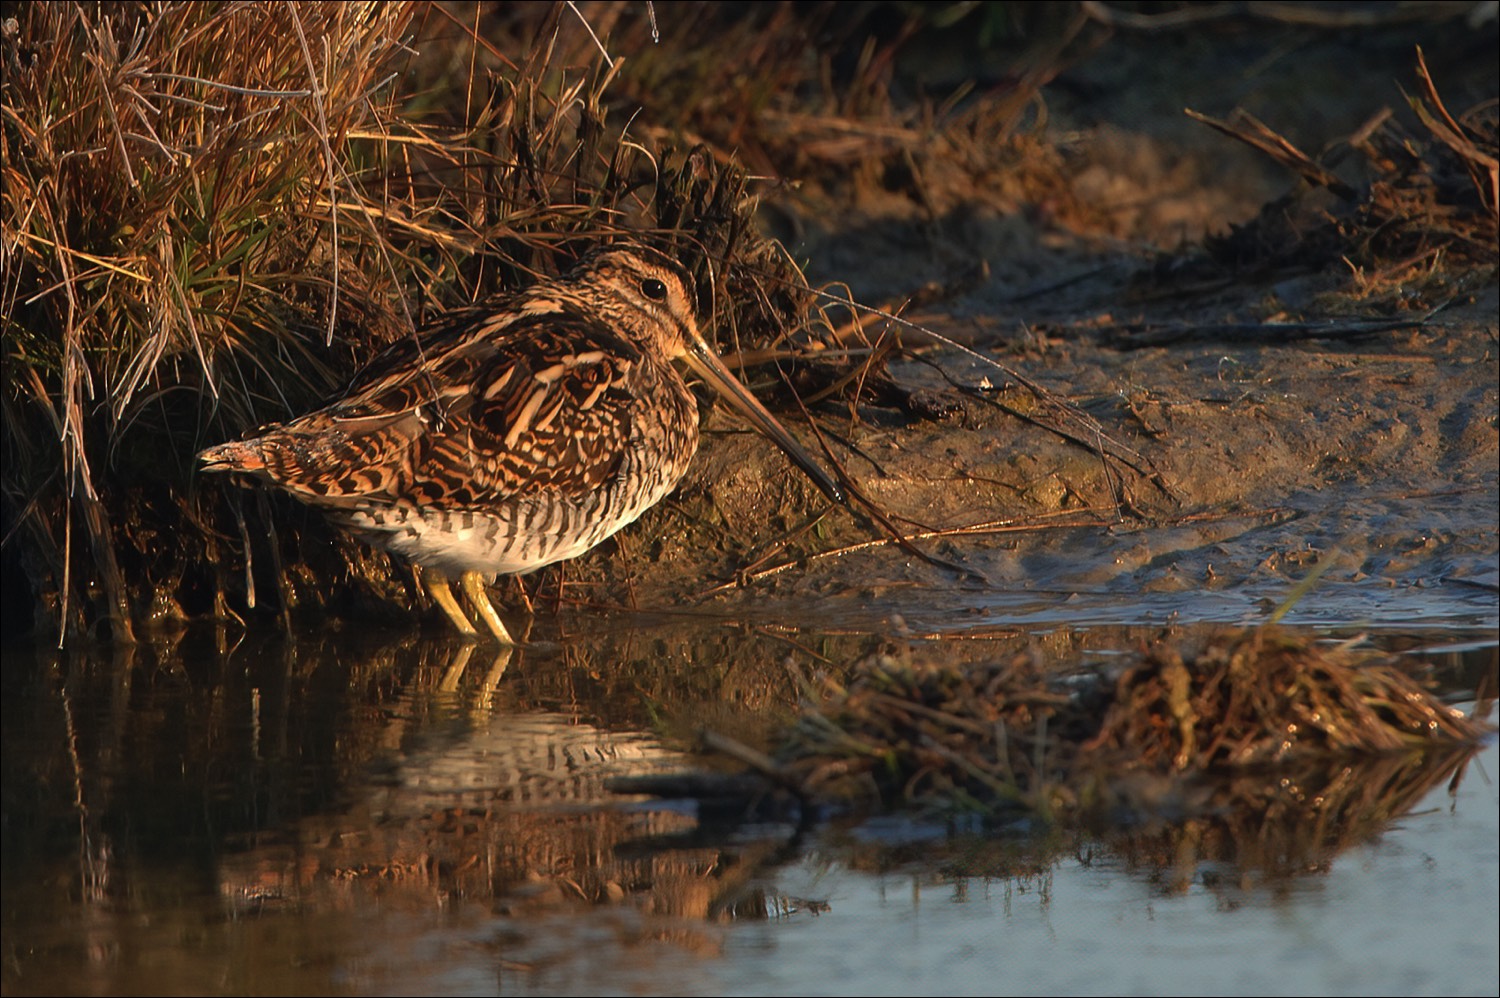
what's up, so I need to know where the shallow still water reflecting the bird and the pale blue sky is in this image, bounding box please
[3,591,1500,995]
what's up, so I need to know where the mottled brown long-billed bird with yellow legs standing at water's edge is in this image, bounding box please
[198,242,845,645]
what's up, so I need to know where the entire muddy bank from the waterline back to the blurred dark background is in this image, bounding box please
[558,15,1500,621]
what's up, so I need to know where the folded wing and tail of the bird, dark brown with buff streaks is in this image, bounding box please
[204,300,654,509]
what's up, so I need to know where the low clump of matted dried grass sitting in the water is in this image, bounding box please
[776,627,1488,818]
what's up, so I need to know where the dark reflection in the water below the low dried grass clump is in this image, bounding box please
[819,735,1476,903]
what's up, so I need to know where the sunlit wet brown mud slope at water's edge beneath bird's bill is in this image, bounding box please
[600,300,1500,633]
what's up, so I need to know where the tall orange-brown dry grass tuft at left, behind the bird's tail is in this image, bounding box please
[0,3,429,638]
